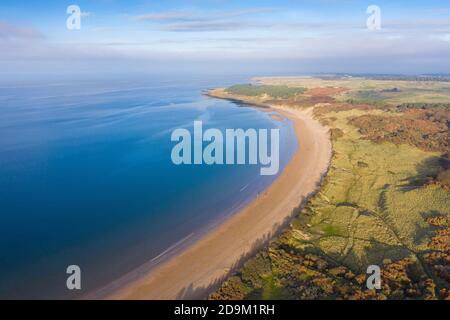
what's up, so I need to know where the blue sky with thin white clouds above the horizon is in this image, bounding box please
[0,0,450,75]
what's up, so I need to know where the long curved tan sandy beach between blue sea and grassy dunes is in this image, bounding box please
[107,92,332,299]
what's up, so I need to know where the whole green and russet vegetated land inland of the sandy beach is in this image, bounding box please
[210,78,450,299]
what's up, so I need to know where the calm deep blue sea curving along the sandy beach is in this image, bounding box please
[0,75,297,299]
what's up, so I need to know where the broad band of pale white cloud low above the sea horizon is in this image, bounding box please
[0,12,450,73]
